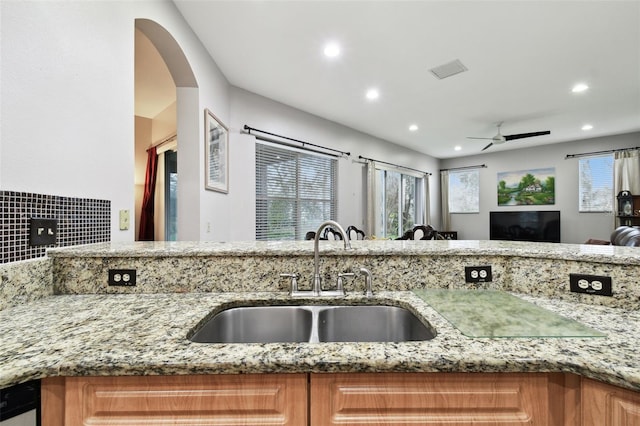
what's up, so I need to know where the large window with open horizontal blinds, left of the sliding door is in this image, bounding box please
[256,143,338,240]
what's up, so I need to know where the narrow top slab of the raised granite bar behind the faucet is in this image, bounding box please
[47,240,640,265]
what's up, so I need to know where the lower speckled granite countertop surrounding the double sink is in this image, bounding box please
[0,291,640,391]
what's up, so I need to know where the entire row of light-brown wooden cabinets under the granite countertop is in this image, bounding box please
[42,373,640,426]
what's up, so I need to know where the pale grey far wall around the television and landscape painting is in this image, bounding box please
[440,133,640,244]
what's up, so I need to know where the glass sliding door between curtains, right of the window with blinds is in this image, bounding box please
[376,169,425,238]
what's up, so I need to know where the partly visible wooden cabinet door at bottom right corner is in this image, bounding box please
[582,379,640,426]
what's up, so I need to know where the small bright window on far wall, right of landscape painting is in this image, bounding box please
[578,154,614,212]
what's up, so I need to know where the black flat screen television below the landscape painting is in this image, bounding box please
[489,210,560,243]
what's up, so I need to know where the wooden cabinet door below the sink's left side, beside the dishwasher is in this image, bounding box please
[43,374,307,426]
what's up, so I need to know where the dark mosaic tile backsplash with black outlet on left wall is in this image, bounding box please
[0,191,111,263]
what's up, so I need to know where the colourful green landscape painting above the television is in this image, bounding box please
[498,167,556,206]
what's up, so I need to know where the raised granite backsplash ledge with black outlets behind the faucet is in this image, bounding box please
[49,241,640,309]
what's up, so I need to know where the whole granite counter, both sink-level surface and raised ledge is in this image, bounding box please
[0,242,640,424]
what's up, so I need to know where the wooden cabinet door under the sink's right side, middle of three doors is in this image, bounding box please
[311,373,564,426]
